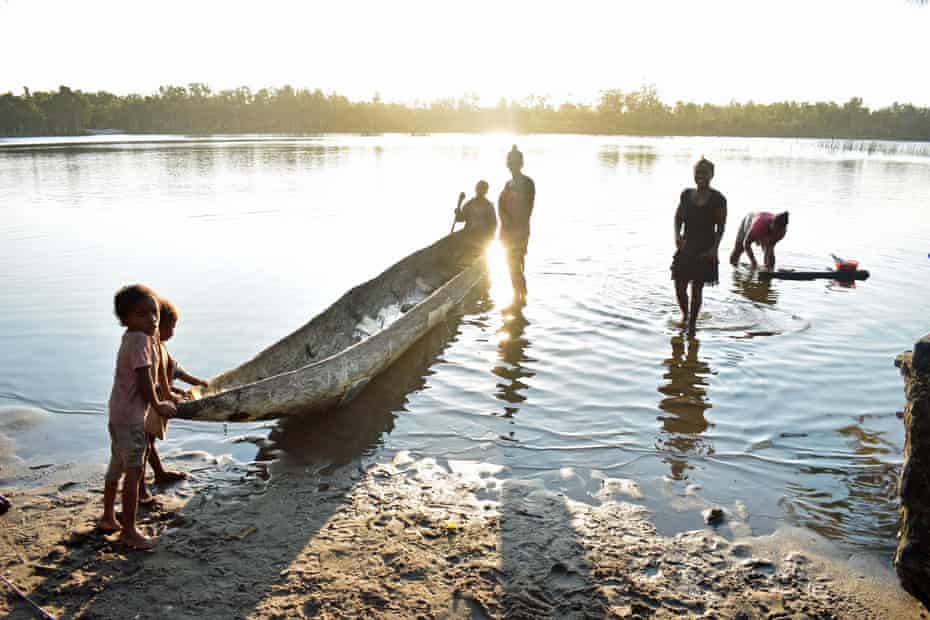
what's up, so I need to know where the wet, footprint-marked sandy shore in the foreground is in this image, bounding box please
[0,454,928,620]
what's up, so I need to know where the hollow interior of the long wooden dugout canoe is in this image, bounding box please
[196,231,483,397]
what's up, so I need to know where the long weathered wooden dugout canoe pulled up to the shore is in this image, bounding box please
[177,230,486,422]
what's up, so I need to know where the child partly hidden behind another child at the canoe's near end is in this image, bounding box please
[139,299,207,502]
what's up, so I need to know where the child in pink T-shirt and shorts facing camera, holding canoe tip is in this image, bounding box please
[99,284,175,549]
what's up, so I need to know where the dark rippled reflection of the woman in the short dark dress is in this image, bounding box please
[657,336,714,480]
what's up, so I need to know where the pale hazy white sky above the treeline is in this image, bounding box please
[0,0,930,107]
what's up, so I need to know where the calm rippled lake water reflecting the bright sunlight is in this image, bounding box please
[0,135,930,554]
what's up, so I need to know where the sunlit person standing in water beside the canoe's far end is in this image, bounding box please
[497,144,536,303]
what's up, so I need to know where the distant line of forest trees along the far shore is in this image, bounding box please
[0,83,930,140]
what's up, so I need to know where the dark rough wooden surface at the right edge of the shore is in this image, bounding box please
[894,334,930,608]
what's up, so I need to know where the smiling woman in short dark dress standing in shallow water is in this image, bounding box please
[672,157,727,334]
